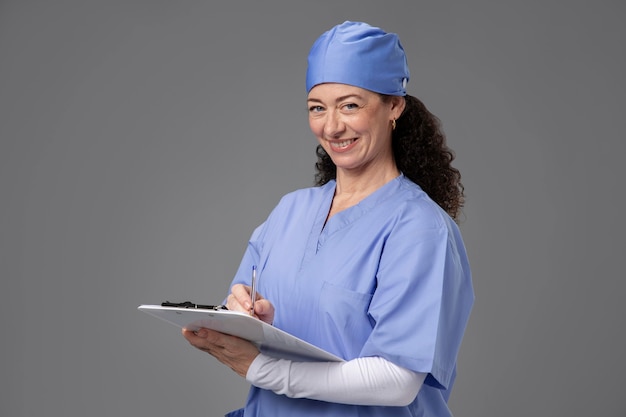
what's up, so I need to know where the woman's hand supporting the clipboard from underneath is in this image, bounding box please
[183,328,259,378]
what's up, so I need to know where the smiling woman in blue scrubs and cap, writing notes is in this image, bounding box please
[183,21,474,417]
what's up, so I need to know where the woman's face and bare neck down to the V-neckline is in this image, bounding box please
[308,83,404,217]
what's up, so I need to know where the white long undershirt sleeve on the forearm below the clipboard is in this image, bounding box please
[246,353,426,406]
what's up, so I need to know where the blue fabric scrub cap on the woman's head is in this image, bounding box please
[306,21,409,96]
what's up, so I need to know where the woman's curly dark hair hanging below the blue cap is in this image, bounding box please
[315,95,465,221]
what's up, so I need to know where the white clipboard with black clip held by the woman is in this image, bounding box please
[138,304,343,362]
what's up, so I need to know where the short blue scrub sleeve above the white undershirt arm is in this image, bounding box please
[362,203,473,389]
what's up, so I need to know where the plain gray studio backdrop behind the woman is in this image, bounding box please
[0,0,626,417]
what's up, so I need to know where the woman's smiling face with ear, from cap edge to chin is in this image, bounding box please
[307,83,404,174]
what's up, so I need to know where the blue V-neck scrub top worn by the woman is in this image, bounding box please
[224,175,474,417]
